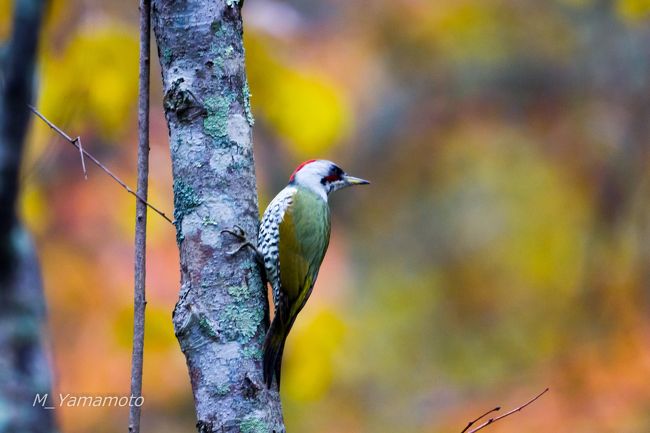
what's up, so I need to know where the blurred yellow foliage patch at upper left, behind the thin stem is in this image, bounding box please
[39,23,138,139]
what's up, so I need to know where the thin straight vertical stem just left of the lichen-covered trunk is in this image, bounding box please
[129,0,151,433]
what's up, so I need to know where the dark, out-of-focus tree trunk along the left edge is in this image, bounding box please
[0,0,54,433]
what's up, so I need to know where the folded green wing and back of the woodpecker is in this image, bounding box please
[279,190,330,321]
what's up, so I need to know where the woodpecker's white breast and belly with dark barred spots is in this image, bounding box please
[257,186,297,305]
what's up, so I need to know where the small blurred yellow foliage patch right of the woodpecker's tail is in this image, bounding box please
[282,308,345,401]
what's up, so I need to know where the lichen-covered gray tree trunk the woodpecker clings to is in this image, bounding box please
[152,0,285,433]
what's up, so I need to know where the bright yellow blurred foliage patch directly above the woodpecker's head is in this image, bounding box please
[245,34,353,158]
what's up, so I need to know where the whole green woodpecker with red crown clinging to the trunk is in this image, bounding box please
[224,159,370,390]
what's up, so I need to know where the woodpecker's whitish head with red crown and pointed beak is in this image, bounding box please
[289,159,370,198]
